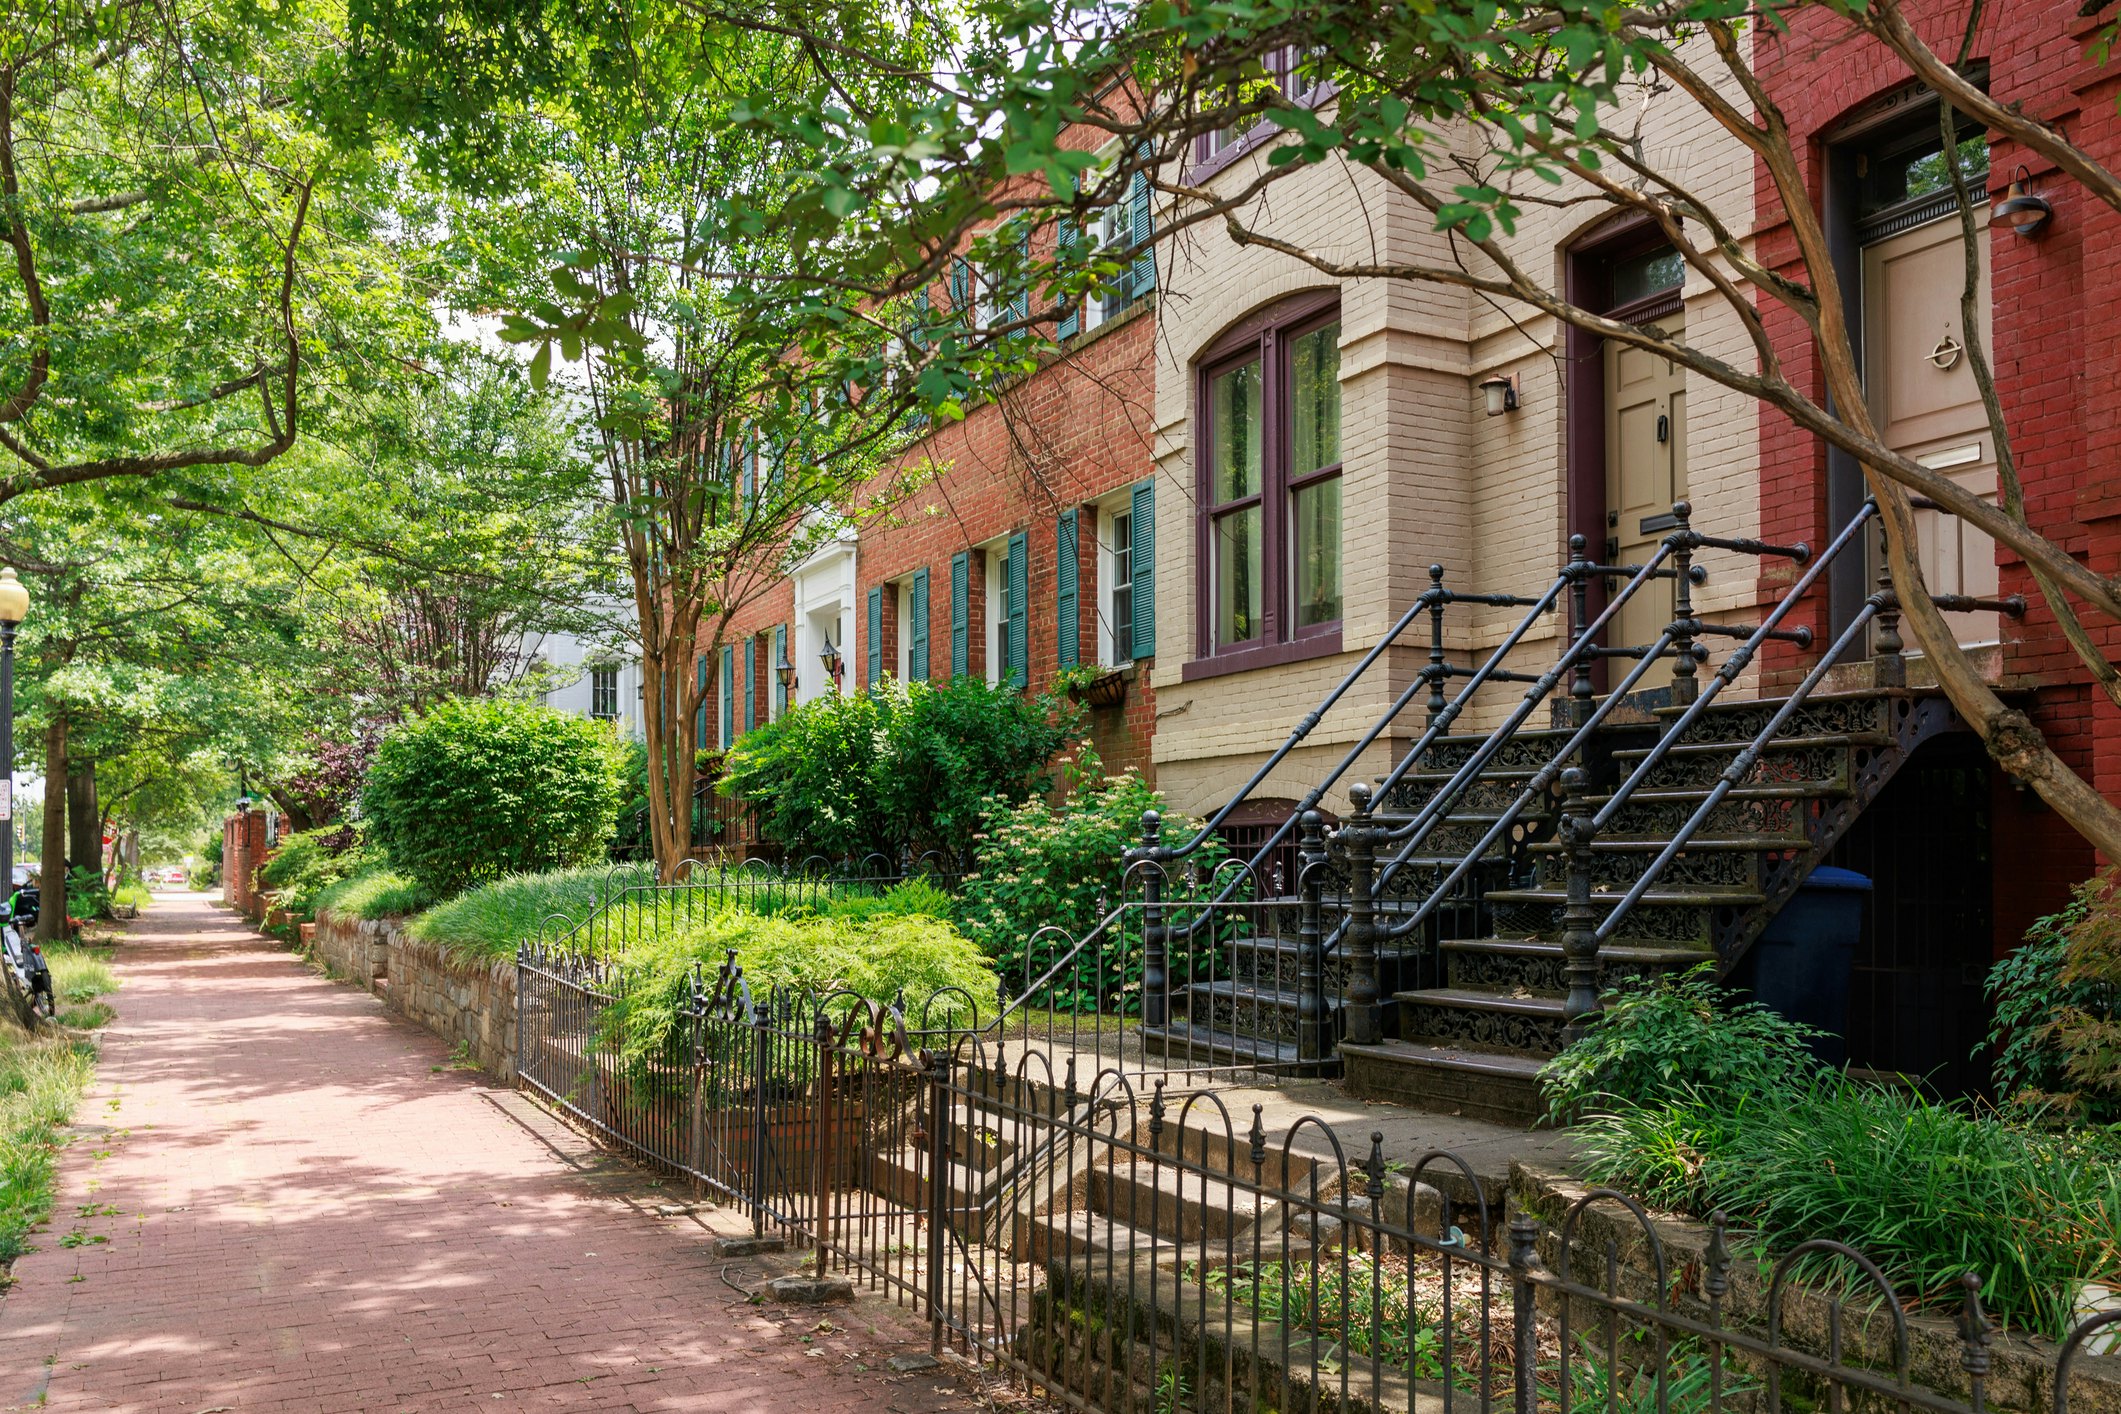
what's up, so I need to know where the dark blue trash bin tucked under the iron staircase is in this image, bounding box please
[1735,865,1871,1066]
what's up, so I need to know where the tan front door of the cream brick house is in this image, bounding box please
[1593,314,1686,687]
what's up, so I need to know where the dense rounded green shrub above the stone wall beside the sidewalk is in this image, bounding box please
[361,697,624,899]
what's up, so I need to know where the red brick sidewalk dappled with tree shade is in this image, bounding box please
[0,895,976,1414]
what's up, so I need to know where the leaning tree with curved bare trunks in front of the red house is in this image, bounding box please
[615,0,2121,859]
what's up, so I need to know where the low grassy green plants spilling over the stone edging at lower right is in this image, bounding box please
[1574,1073,2121,1336]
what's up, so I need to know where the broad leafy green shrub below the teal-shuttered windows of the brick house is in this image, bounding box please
[719,678,1082,865]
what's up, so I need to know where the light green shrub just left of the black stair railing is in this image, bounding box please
[957,772,1247,1011]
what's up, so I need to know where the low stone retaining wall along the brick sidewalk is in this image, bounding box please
[310,914,515,1081]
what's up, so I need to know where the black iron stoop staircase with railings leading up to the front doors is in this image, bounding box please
[1133,502,2023,1124]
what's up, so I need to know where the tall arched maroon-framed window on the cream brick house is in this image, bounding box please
[1198,297,1340,655]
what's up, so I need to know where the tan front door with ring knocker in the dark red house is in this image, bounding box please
[1862,208,2002,644]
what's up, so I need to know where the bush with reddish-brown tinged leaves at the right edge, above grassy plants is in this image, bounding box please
[1987,871,2121,1124]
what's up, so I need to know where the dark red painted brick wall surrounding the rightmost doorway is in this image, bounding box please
[1756,0,2121,948]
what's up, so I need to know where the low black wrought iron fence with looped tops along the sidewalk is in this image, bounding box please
[518,950,2121,1414]
